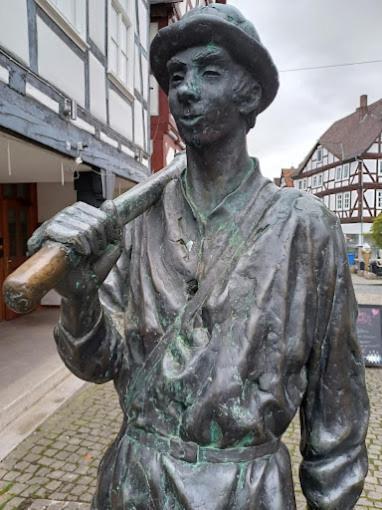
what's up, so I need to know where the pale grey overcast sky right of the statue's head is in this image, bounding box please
[227,0,382,177]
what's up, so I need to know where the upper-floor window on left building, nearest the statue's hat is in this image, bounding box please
[109,0,134,90]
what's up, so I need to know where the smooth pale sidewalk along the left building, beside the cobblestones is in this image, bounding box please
[0,309,82,460]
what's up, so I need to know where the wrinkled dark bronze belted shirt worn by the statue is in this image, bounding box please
[56,161,368,510]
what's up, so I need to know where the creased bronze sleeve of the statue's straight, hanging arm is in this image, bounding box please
[300,218,369,510]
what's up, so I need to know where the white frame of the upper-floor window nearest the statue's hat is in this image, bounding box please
[107,0,135,103]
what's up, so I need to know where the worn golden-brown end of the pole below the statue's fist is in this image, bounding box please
[3,243,68,313]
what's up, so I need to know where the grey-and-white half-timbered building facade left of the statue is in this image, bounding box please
[0,0,150,320]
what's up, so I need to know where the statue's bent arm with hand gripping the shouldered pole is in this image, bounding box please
[28,202,129,382]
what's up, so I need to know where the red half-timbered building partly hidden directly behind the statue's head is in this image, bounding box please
[150,0,226,172]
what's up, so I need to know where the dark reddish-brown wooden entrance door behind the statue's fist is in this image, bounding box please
[0,184,37,320]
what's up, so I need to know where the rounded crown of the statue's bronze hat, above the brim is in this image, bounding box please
[182,4,261,43]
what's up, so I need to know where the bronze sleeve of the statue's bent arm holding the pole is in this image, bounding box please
[54,228,131,383]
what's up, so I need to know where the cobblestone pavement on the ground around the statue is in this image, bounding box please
[0,369,382,510]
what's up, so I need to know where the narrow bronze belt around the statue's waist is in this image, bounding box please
[127,427,280,464]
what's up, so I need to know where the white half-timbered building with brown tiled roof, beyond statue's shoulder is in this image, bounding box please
[293,95,382,246]
